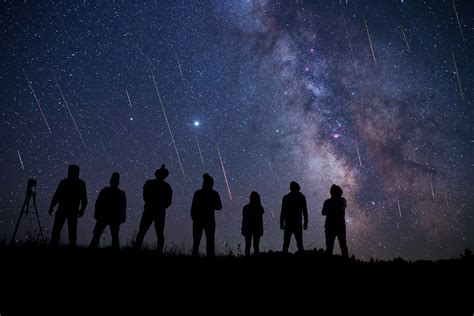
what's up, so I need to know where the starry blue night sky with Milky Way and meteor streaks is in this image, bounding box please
[0,0,474,259]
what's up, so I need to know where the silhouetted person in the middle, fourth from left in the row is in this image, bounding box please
[191,173,222,257]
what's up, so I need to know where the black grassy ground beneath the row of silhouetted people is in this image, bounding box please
[0,245,474,316]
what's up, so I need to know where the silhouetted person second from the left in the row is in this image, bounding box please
[90,172,127,249]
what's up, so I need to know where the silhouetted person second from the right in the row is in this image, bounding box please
[280,181,308,253]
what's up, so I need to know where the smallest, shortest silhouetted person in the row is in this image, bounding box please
[242,192,264,256]
